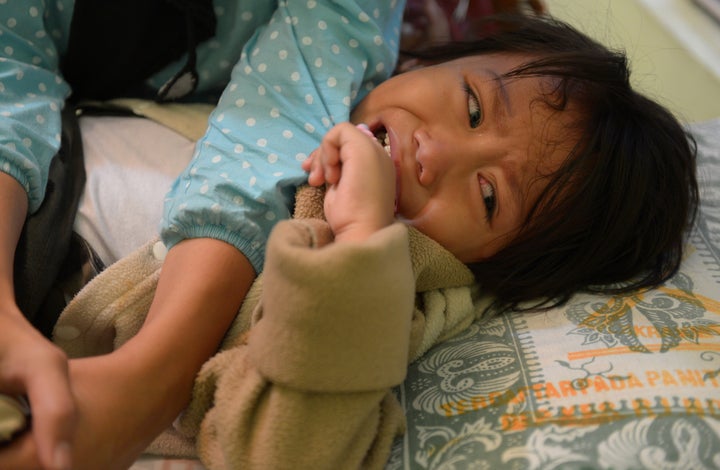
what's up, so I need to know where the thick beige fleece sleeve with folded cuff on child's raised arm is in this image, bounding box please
[198,221,414,469]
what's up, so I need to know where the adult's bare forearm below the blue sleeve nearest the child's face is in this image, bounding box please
[0,239,254,470]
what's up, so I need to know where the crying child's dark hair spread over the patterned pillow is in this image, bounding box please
[404,17,698,309]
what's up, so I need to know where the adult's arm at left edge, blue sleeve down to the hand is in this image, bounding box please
[0,0,75,468]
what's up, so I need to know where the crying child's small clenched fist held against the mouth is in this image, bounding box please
[302,123,395,241]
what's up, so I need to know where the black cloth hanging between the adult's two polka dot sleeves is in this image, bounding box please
[61,0,216,101]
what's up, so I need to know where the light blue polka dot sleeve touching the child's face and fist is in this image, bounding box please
[161,0,404,272]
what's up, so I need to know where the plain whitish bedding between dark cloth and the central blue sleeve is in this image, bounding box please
[75,116,195,265]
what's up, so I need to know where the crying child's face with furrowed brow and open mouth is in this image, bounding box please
[352,54,576,262]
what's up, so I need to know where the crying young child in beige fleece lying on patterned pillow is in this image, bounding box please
[114,12,696,468]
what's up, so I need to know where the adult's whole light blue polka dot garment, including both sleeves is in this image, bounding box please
[0,0,405,272]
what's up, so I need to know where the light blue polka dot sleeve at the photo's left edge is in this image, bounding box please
[0,0,70,212]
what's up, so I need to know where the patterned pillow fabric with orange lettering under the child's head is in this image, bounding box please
[388,120,720,470]
